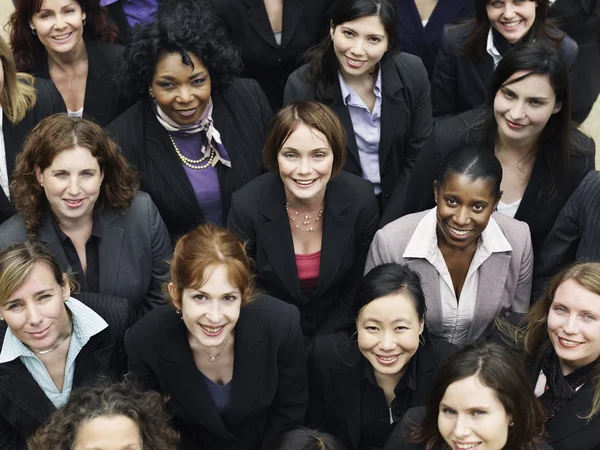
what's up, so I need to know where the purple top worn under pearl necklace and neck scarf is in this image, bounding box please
[170,132,229,226]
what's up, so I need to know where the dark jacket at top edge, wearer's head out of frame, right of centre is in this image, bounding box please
[396,0,475,79]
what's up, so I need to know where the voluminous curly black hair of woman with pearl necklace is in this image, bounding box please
[115,2,242,98]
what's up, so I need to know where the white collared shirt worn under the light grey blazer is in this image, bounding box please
[402,208,512,345]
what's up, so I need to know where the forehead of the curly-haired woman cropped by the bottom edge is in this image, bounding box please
[73,416,142,450]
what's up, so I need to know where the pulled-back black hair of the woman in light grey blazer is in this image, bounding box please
[436,144,502,198]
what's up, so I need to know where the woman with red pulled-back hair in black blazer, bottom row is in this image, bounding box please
[125,224,308,450]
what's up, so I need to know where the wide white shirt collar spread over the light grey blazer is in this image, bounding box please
[402,208,512,261]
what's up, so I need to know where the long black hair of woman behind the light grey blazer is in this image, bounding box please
[484,42,577,197]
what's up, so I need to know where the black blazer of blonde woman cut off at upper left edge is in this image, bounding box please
[0,78,65,224]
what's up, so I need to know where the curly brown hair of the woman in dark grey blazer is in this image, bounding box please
[10,113,139,240]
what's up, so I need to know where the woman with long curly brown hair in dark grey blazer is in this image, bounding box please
[0,114,171,318]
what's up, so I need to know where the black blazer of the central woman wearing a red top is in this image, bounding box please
[227,171,378,336]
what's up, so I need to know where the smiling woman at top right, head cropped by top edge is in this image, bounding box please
[431,0,577,117]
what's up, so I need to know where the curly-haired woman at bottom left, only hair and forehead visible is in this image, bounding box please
[28,380,178,450]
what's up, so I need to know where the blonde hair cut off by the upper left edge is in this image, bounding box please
[0,37,37,124]
